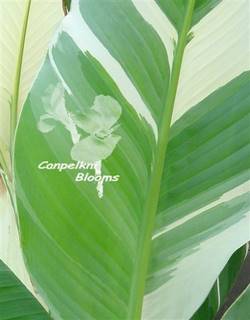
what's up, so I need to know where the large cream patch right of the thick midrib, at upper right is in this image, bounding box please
[172,0,250,123]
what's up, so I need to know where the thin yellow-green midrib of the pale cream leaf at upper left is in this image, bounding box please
[10,0,31,149]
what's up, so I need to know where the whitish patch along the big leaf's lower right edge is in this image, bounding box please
[143,211,250,320]
